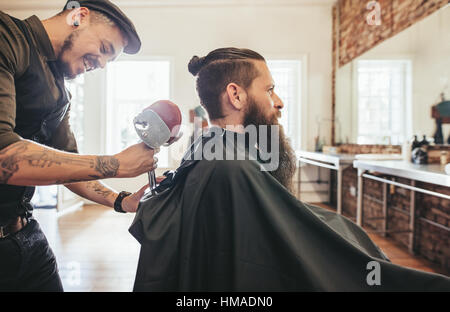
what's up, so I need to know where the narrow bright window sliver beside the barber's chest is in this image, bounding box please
[65,75,84,153]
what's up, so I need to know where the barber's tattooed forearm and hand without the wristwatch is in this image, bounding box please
[0,140,156,186]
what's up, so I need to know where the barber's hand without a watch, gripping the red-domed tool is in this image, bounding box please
[114,143,159,178]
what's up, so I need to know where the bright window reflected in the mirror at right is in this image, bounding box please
[356,60,411,144]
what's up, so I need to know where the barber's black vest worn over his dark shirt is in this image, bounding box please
[0,16,69,226]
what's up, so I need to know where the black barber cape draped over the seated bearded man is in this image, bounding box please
[130,128,450,291]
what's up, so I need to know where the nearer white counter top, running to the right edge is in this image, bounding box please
[353,160,450,187]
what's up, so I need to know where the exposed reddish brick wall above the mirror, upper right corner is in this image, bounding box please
[337,0,450,66]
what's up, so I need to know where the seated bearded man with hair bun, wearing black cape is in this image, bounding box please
[130,48,450,291]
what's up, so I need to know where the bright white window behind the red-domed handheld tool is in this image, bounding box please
[107,60,170,167]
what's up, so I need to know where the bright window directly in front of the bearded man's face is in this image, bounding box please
[267,60,302,149]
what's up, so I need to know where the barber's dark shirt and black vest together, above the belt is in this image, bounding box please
[0,11,77,225]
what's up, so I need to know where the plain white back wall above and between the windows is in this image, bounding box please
[0,1,332,199]
